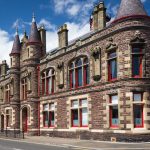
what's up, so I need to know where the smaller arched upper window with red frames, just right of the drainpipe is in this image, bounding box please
[42,69,55,95]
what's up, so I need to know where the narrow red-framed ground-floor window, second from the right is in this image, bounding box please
[109,95,119,128]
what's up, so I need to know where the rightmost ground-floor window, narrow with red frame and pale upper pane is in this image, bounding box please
[133,92,144,128]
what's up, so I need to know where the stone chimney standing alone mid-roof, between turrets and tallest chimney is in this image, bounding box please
[58,24,68,48]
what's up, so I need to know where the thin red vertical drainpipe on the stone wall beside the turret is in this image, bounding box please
[37,65,40,136]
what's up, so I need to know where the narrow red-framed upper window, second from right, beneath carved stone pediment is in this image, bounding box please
[108,51,117,81]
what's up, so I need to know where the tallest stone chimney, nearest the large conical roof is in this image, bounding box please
[93,2,106,30]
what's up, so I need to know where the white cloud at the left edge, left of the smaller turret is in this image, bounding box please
[0,29,13,65]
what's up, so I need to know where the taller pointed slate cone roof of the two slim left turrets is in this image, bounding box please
[29,15,41,42]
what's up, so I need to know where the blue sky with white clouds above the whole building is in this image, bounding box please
[0,0,150,64]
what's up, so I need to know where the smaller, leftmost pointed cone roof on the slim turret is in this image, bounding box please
[10,30,21,55]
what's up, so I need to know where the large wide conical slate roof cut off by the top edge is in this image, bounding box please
[116,0,147,19]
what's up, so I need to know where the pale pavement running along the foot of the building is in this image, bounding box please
[20,136,150,149]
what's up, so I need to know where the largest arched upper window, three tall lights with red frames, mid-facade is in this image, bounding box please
[69,58,89,88]
